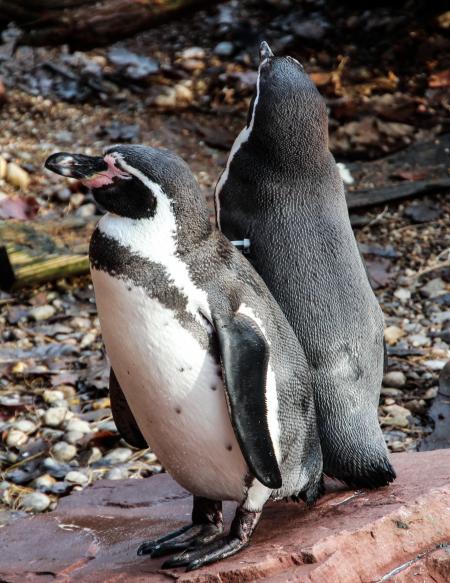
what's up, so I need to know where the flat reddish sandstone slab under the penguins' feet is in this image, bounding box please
[0,450,450,583]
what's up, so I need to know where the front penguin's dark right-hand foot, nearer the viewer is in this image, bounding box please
[162,507,261,571]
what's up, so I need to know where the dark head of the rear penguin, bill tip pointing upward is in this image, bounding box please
[247,42,328,157]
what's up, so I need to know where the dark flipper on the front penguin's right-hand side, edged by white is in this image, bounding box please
[214,314,282,489]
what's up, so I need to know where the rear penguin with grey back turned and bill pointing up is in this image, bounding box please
[215,42,395,488]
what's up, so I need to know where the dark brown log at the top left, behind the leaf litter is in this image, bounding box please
[0,0,218,48]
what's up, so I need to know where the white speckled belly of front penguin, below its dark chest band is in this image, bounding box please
[91,268,248,502]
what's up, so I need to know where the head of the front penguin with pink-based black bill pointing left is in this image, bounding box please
[45,145,209,240]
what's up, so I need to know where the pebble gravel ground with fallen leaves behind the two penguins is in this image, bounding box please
[0,1,450,525]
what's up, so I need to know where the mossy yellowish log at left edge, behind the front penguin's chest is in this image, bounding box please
[0,218,95,291]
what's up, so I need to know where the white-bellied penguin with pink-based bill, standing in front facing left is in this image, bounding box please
[46,145,322,570]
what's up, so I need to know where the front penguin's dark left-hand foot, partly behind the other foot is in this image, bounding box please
[137,496,223,558]
